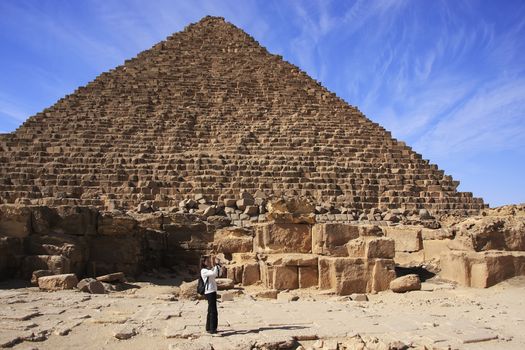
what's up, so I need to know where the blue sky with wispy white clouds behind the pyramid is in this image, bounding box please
[0,0,525,206]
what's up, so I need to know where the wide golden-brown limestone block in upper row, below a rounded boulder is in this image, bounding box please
[253,223,312,253]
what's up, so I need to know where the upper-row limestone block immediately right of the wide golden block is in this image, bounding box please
[312,223,359,256]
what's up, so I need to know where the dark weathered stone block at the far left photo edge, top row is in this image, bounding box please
[0,204,31,238]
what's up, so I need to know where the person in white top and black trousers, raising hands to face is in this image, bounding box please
[201,256,221,334]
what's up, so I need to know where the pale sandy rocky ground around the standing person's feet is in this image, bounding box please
[0,277,525,350]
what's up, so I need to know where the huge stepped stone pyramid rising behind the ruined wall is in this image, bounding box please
[0,17,485,214]
